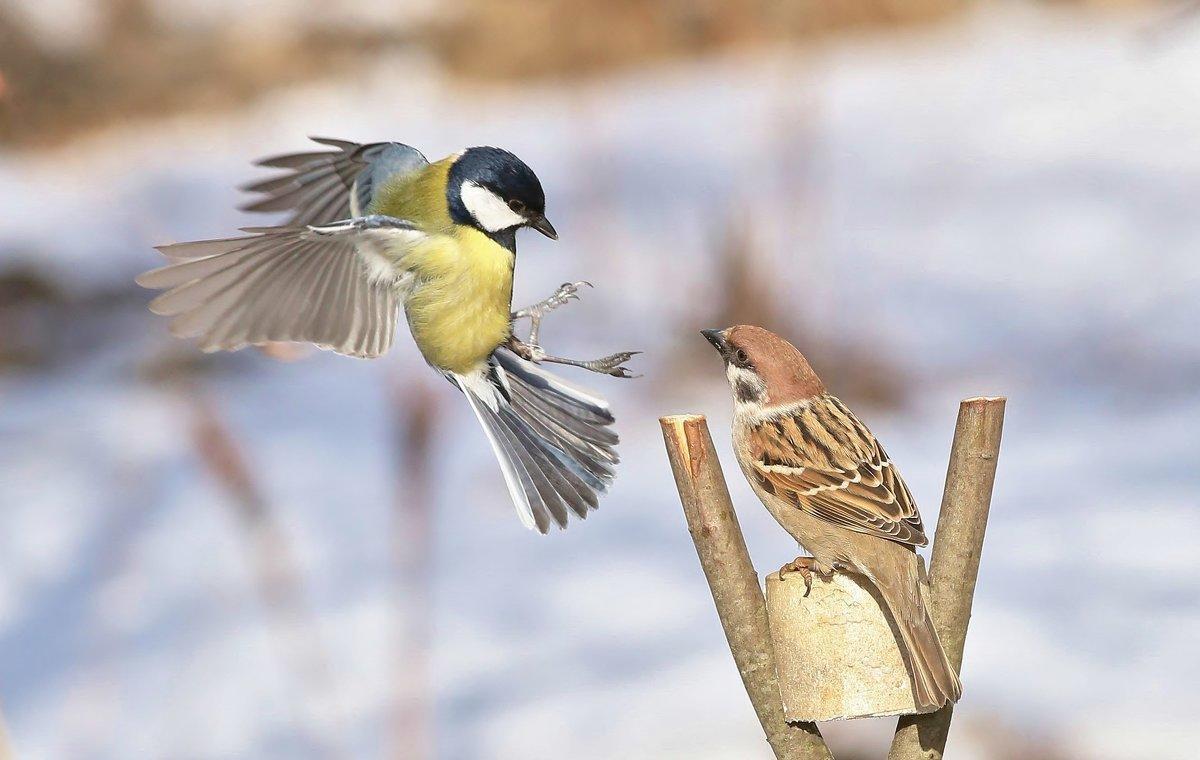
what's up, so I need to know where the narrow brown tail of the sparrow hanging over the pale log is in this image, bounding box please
[871,552,962,712]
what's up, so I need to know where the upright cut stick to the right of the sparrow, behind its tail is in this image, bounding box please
[888,397,1004,760]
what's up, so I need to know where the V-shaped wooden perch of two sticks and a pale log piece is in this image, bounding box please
[659,397,1004,760]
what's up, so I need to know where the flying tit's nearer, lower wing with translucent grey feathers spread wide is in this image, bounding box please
[137,216,426,358]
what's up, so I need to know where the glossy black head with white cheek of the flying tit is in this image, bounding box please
[446,146,558,238]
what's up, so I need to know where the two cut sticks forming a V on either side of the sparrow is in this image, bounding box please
[659,397,1004,760]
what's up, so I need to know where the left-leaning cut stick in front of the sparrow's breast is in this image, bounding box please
[659,415,833,760]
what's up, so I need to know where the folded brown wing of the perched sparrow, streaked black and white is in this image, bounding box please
[749,395,929,546]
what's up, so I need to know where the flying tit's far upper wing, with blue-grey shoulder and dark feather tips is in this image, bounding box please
[242,137,428,226]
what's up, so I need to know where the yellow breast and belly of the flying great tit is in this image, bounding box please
[406,226,516,373]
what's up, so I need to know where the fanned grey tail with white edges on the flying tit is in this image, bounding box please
[449,348,618,533]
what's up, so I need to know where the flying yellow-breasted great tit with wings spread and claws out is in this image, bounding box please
[137,138,632,533]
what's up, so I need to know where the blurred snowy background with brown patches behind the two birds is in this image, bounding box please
[0,0,1200,760]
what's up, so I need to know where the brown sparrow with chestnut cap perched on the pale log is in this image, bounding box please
[701,325,962,711]
